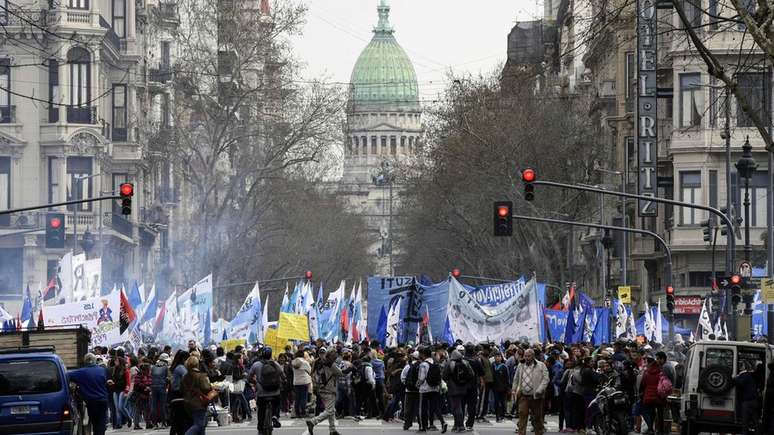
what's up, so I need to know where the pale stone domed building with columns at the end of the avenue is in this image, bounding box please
[339,0,422,274]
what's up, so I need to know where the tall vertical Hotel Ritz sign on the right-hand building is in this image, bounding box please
[637,0,658,216]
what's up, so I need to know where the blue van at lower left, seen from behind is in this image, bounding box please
[0,348,83,435]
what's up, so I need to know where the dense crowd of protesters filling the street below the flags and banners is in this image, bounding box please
[63,341,774,435]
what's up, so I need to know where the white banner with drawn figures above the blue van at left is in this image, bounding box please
[43,292,121,347]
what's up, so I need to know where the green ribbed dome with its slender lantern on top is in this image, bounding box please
[350,0,419,110]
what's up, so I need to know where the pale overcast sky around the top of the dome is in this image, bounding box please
[295,0,542,98]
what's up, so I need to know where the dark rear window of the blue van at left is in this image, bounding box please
[0,361,62,396]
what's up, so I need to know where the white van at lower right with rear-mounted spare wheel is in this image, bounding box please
[679,340,773,435]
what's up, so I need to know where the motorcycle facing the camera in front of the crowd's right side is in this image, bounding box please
[586,379,632,435]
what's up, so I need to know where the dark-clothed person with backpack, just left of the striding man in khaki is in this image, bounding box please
[249,346,284,434]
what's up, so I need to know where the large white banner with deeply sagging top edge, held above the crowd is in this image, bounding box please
[447,278,540,343]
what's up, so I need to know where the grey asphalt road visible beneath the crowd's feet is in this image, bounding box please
[108,416,559,435]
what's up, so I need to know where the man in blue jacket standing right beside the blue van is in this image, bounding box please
[67,353,108,435]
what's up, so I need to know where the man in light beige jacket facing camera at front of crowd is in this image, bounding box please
[513,349,548,435]
